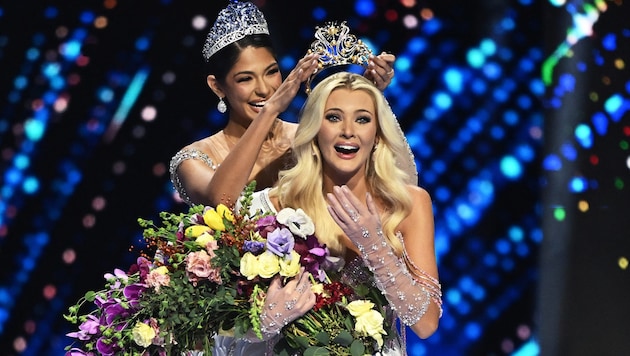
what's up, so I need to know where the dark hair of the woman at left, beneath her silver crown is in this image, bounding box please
[205,34,276,84]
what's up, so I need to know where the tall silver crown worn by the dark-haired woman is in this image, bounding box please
[202,0,269,61]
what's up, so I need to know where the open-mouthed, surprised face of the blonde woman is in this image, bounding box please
[317,89,377,184]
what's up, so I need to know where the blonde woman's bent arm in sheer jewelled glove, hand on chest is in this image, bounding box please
[328,186,442,338]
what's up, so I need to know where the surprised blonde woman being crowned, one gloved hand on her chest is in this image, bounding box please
[244,72,441,355]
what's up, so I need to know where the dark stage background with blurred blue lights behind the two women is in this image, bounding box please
[0,0,630,356]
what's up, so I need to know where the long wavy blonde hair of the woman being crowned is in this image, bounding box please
[270,72,411,256]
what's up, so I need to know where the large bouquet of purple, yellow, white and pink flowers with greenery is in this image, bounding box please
[64,182,398,356]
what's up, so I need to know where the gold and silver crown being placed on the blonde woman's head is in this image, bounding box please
[306,21,372,94]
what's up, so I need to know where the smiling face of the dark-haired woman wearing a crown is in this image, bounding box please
[224,47,282,121]
